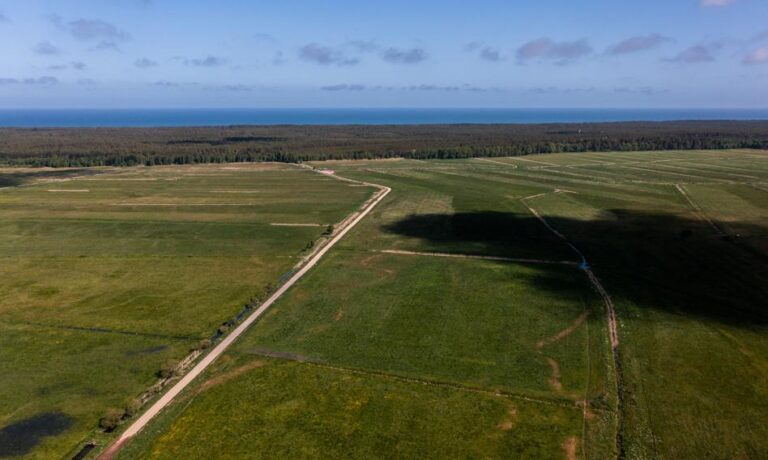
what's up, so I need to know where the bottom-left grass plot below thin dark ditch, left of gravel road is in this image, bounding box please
[0,322,195,459]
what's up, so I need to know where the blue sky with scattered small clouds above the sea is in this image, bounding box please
[0,0,768,108]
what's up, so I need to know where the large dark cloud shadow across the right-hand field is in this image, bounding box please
[385,210,768,326]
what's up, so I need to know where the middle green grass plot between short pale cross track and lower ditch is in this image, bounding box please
[238,251,604,400]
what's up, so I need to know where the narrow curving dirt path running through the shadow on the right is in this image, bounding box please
[520,193,626,459]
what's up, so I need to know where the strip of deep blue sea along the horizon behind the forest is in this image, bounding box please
[0,109,768,128]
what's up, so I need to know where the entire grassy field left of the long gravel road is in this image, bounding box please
[0,164,371,458]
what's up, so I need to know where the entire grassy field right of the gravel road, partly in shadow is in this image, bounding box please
[118,151,768,458]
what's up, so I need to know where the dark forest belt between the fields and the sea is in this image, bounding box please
[0,121,768,167]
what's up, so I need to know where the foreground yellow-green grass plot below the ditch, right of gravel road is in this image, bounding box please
[120,355,582,459]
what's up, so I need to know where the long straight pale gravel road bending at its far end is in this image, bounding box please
[99,169,392,459]
